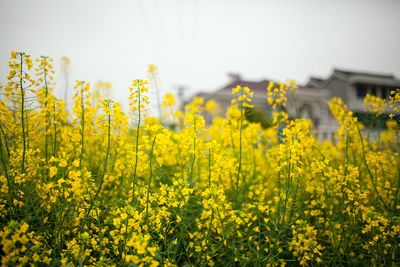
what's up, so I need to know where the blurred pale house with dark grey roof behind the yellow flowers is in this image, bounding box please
[197,69,400,140]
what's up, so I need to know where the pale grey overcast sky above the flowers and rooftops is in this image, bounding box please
[0,0,400,109]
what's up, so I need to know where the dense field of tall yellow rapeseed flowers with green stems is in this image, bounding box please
[0,52,400,266]
